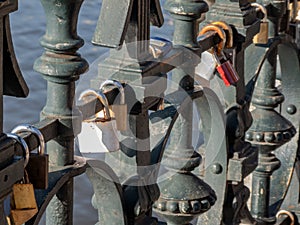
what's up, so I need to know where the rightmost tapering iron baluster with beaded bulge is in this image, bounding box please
[246,49,296,221]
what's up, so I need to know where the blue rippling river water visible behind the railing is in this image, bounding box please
[4,0,173,225]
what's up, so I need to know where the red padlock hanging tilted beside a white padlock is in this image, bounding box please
[213,48,239,86]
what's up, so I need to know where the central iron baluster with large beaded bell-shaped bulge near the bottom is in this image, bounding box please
[154,0,215,225]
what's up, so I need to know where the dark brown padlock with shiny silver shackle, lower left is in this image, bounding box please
[12,124,49,189]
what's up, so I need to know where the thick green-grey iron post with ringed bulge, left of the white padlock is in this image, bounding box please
[34,0,88,225]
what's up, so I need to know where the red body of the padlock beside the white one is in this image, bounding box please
[217,60,239,86]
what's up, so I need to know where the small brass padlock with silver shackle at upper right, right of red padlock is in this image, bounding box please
[251,2,269,44]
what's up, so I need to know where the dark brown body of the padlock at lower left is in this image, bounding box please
[26,153,49,189]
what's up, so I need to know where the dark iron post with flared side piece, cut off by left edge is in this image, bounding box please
[0,0,28,225]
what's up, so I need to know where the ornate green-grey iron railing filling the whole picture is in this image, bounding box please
[0,0,300,225]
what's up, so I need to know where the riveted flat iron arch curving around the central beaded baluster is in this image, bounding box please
[152,87,228,224]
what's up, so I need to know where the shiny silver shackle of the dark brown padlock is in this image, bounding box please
[11,124,45,155]
